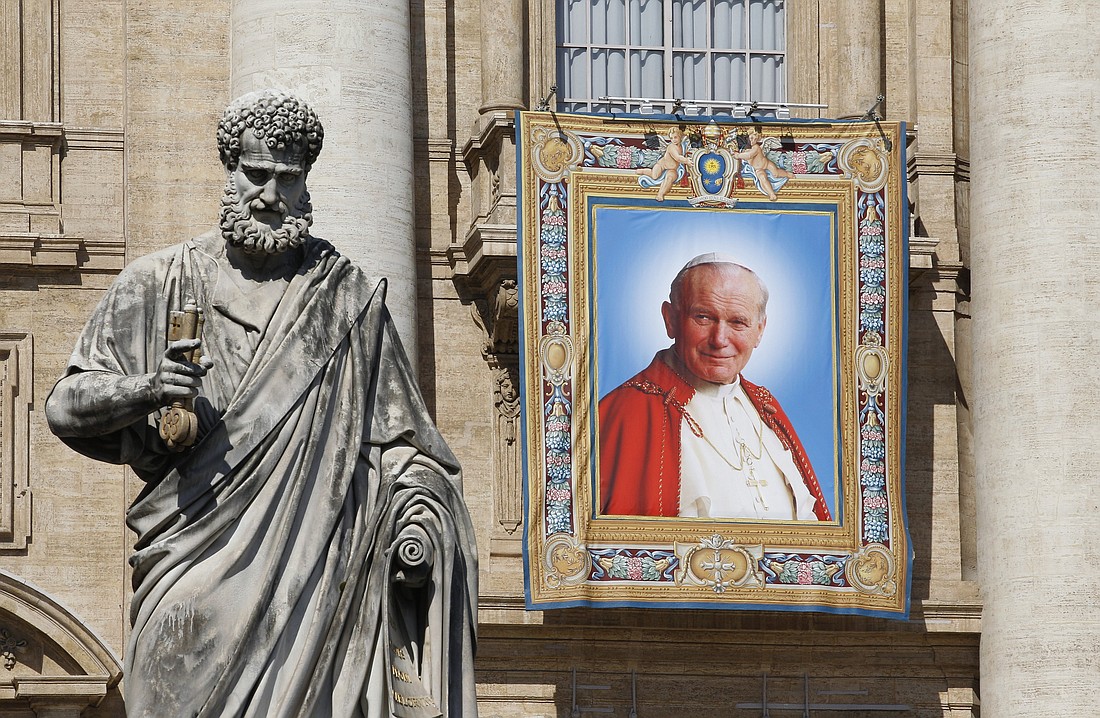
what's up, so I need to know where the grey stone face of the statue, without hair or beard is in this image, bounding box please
[232,130,306,230]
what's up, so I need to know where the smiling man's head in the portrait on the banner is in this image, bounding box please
[661,264,767,384]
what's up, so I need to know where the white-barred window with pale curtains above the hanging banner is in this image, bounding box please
[558,0,787,114]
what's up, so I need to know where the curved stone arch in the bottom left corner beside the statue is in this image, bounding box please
[0,570,122,717]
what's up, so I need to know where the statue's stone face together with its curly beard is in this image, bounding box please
[221,130,314,254]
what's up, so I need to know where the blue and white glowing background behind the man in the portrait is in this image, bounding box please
[590,200,839,518]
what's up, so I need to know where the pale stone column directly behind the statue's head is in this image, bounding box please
[230,0,417,363]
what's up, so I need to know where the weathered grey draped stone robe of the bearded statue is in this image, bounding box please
[53,234,477,717]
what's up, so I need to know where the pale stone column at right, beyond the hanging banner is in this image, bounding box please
[969,0,1100,718]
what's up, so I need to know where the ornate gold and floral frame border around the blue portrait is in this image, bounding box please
[516,112,912,618]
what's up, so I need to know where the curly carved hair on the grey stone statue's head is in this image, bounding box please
[218,90,325,172]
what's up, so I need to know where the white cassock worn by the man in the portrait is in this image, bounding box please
[680,377,817,521]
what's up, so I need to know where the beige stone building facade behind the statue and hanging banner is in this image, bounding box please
[8,0,1086,718]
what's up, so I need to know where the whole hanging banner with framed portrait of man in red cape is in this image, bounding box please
[516,112,912,618]
